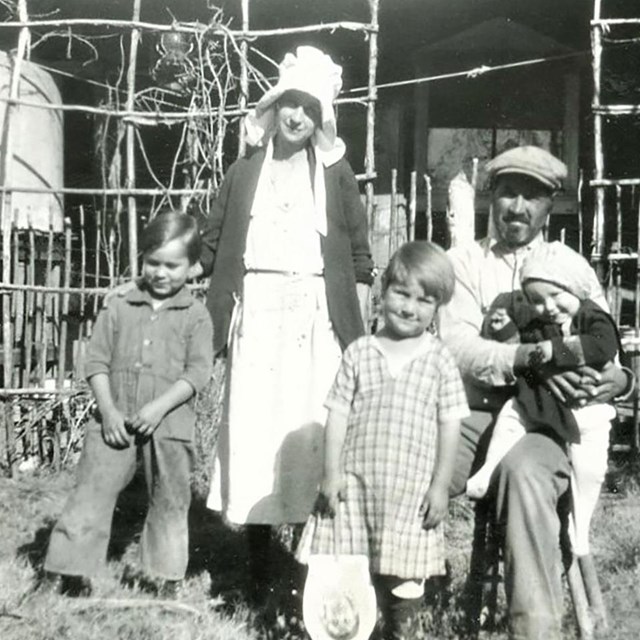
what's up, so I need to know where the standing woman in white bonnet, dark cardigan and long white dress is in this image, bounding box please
[201,47,373,590]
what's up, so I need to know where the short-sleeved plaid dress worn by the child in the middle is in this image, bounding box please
[301,334,468,579]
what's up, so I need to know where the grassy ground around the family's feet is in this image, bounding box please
[0,370,640,640]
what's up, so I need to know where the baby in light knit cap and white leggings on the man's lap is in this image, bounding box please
[466,242,621,556]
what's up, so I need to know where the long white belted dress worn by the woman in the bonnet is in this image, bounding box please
[208,152,341,525]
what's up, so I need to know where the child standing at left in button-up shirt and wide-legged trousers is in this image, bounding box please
[44,212,213,597]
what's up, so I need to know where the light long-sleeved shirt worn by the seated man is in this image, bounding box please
[438,235,608,409]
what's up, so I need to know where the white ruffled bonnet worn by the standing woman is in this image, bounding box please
[244,46,342,152]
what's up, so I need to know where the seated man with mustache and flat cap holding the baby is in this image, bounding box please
[440,146,632,640]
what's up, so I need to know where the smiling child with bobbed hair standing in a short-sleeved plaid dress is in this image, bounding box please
[301,242,468,639]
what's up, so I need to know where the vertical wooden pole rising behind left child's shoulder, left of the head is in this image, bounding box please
[125,0,142,278]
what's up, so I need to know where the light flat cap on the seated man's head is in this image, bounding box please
[486,146,567,191]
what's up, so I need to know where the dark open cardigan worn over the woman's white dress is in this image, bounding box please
[200,148,373,354]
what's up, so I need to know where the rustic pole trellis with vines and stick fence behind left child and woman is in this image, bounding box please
[0,0,379,471]
